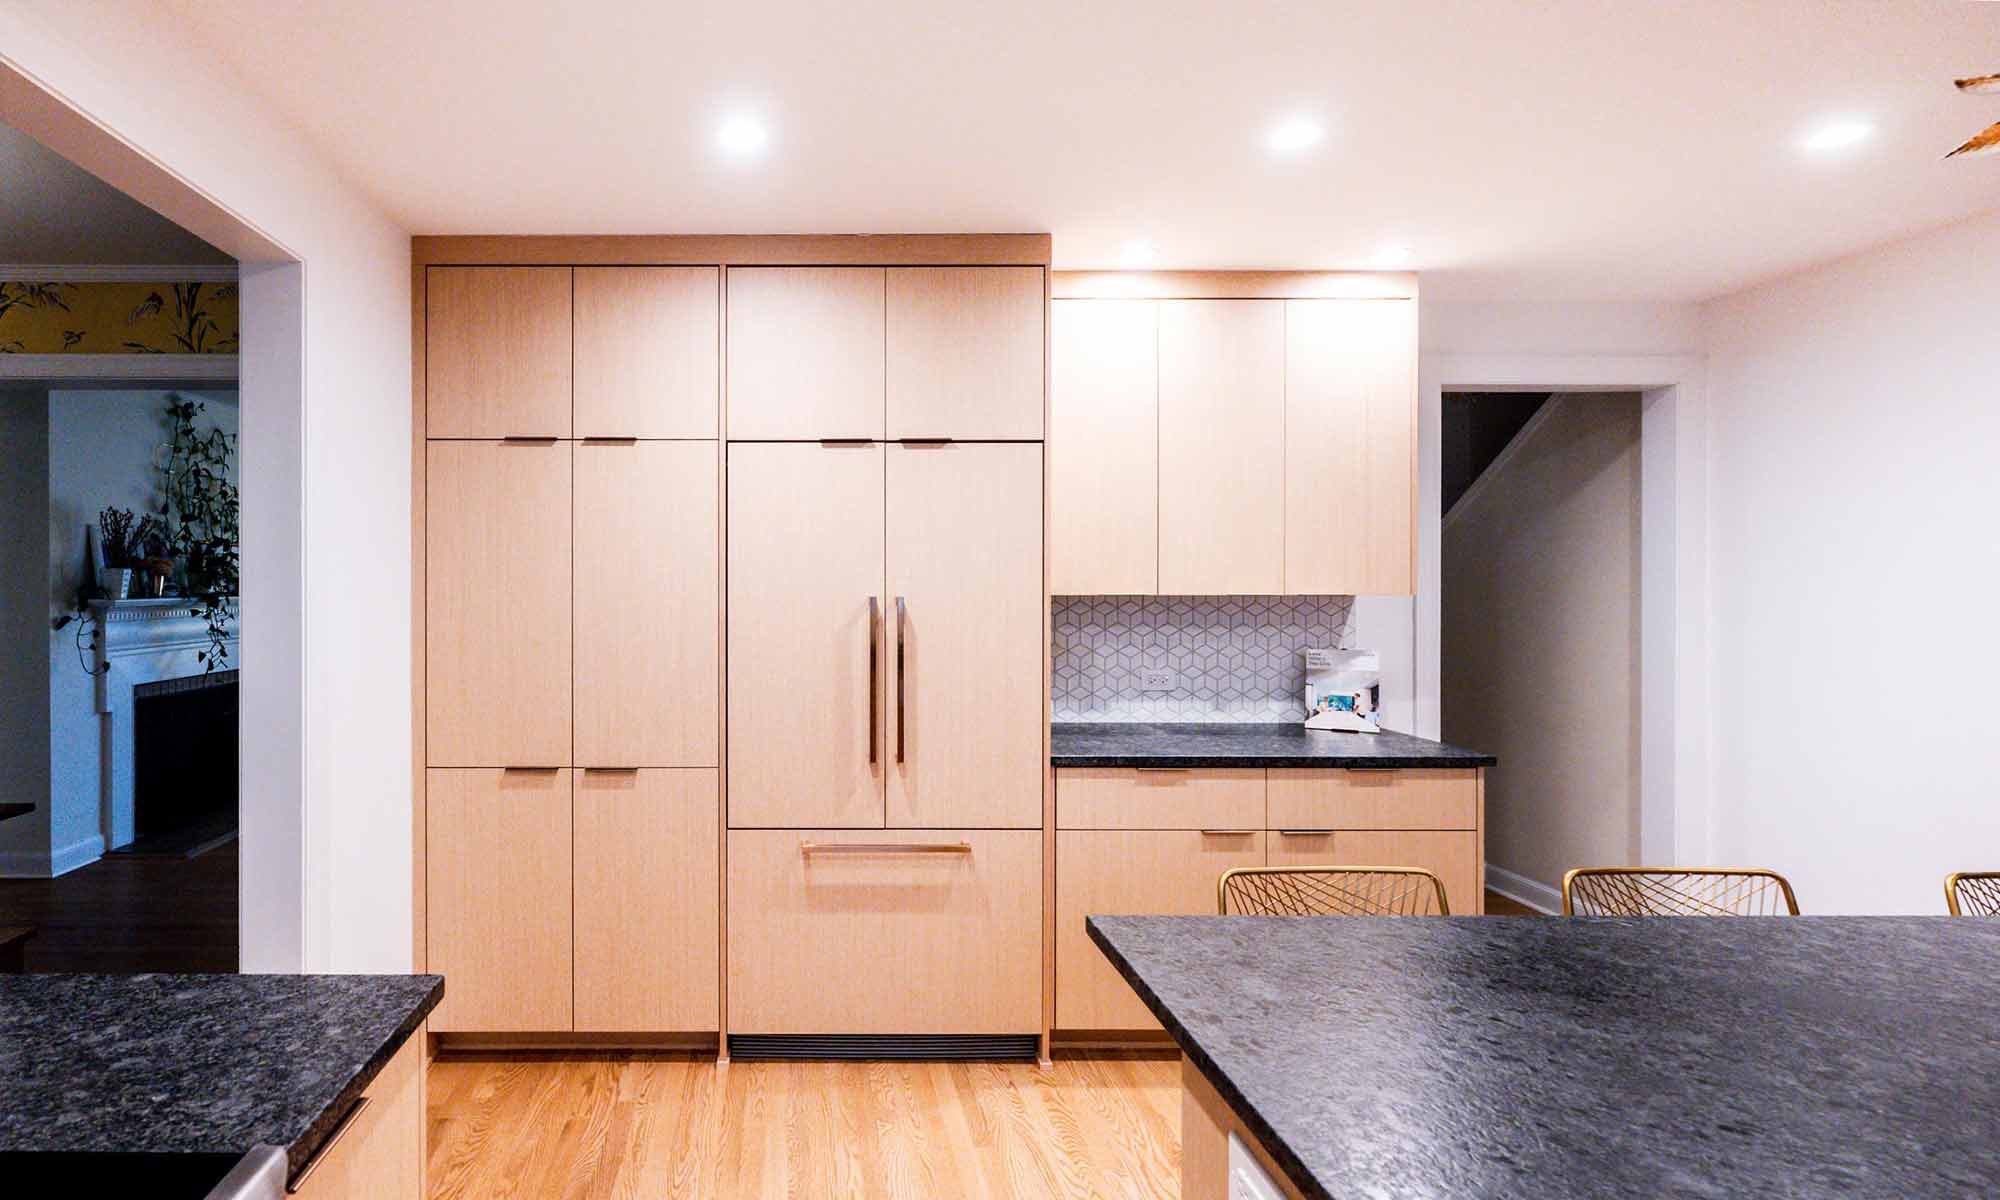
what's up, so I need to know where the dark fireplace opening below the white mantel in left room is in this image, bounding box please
[124,670,238,858]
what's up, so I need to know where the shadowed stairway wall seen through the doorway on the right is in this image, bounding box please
[1440,394,1640,898]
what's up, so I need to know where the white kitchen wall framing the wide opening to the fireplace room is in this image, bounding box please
[0,0,410,970]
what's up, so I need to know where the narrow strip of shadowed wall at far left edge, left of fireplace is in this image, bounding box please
[0,388,50,876]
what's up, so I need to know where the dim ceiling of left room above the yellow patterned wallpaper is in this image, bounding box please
[0,122,236,266]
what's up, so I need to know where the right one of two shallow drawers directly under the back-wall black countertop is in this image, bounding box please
[1270,768,1480,830]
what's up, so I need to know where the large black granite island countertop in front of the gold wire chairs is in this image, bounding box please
[1088,916,2000,1200]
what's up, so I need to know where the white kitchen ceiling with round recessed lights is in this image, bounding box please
[170,0,2000,300]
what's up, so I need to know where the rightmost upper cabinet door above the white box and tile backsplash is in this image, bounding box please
[1284,300,1416,596]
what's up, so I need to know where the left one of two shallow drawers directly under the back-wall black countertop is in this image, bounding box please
[1056,766,1264,830]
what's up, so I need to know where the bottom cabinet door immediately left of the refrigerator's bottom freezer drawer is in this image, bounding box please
[576,770,722,1032]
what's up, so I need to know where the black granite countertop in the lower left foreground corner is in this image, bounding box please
[0,974,444,1172]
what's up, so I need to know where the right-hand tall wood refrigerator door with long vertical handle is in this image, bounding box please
[886,442,1046,828]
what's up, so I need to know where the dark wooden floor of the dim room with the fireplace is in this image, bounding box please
[0,842,238,974]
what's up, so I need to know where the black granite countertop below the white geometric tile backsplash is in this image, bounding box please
[1050,722,1496,770]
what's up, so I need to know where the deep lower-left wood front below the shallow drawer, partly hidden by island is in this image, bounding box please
[1056,828,1264,1030]
